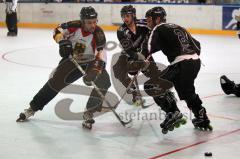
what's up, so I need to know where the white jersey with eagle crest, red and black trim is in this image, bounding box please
[53,20,107,62]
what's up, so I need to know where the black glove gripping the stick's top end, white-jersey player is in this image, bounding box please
[59,40,73,58]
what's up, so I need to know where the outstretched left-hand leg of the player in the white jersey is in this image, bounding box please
[16,59,82,120]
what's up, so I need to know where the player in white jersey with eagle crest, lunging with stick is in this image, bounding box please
[15,7,111,128]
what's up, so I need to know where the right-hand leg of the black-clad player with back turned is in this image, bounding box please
[175,60,212,130]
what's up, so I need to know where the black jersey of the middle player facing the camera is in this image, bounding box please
[117,20,150,56]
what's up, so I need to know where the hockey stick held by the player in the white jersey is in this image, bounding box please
[71,58,132,127]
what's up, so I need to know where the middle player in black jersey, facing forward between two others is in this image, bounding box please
[113,5,166,103]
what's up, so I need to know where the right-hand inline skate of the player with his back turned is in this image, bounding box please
[192,107,213,131]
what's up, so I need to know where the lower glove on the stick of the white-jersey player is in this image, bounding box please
[83,60,106,86]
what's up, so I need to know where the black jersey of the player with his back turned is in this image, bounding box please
[148,23,200,62]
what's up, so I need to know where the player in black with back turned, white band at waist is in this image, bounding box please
[146,7,212,133]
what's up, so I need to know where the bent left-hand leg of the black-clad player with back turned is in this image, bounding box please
[144,63,186,134]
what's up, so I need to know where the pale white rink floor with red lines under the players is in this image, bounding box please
[0,28,240,159]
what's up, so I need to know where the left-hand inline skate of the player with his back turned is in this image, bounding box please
[160,111,187,134]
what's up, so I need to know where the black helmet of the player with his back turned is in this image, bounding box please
[145,7,167,22]
